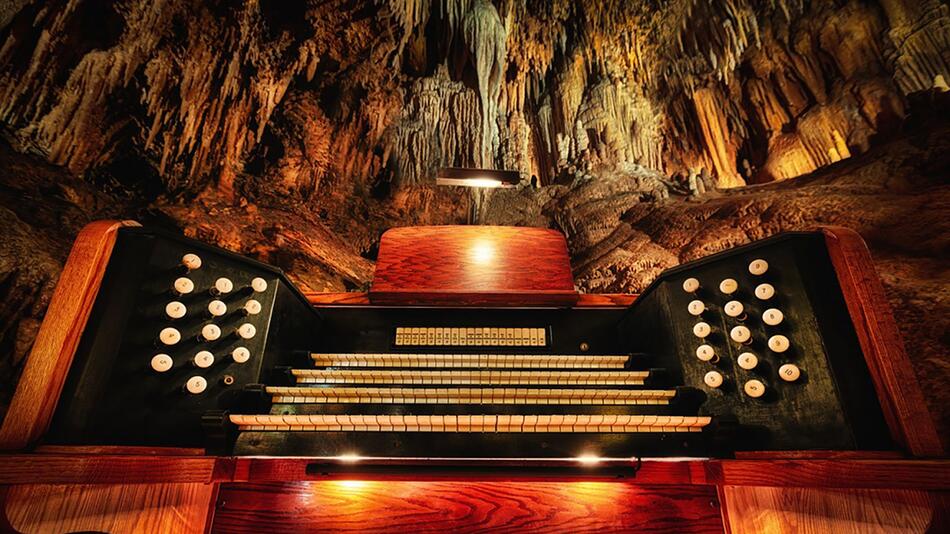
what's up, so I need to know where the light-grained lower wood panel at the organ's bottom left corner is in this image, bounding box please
[0,484,217,534]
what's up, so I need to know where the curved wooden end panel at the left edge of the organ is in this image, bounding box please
[0,221,138,450]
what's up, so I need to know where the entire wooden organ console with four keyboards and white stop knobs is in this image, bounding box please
[0,221,950,532]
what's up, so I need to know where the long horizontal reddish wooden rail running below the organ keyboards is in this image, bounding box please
[0,452,950,491]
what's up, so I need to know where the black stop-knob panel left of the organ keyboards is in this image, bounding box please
[47,228,319,447]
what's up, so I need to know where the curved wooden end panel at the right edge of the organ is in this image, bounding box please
[821,226,943,456]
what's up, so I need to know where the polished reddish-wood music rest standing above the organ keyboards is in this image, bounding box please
[369,226,577,306]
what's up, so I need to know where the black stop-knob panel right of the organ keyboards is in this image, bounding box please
[621,233,891,450]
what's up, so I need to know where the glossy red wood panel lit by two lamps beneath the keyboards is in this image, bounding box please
[212,481,722,533]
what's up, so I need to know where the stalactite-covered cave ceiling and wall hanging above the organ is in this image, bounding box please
[0,0,950,193]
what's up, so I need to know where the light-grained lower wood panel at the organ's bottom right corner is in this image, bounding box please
[720,486,950,534]
